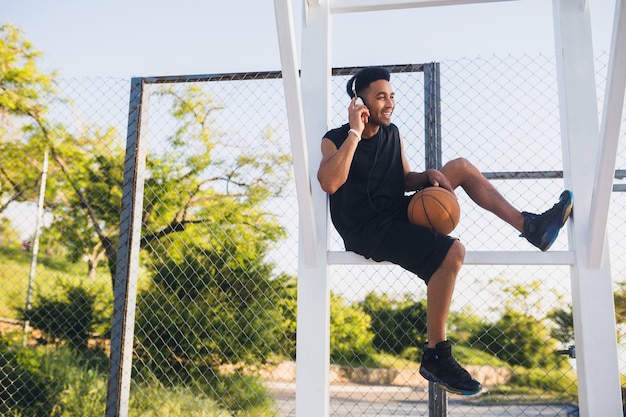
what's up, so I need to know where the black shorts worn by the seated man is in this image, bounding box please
[369,220,457,284]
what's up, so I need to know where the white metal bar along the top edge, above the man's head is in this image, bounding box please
[330,0,516,14]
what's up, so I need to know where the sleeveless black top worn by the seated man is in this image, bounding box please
[324,124,406,256]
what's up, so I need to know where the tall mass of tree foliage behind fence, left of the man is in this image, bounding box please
[129,86,295,375]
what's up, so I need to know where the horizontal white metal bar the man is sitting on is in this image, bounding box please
[328,251,575,265]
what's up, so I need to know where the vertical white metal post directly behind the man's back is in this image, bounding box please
[296,0,331,417]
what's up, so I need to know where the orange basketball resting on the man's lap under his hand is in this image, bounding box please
[407,187,461,235]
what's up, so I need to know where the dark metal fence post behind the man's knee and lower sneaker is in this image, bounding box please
[424,62,448,417]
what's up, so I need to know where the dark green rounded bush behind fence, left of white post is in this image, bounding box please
[136,236,296,376]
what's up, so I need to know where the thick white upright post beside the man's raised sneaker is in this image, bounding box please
[553,0,622,417]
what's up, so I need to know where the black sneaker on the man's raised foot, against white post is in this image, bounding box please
[520,190,574,251]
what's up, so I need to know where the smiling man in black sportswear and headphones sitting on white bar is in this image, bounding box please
[317,67,573,395]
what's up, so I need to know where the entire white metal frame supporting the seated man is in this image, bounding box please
[274,0,626,417]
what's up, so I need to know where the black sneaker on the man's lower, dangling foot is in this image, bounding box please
[420,340,483,395]
